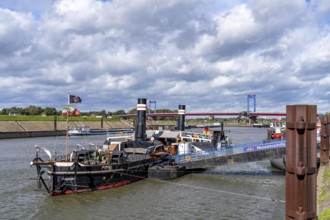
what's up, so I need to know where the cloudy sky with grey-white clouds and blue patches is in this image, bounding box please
[0,0,330,113]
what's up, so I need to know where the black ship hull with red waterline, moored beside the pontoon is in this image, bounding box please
[40,158,155,195]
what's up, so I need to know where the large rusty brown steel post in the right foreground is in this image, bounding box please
[286,105,317,220]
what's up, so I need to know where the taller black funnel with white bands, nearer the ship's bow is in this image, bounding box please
[135,98,147,141]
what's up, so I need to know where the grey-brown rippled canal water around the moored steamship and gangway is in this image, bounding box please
[0,127,285,220]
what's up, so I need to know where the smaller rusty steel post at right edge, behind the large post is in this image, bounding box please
[320,115,330,165]
